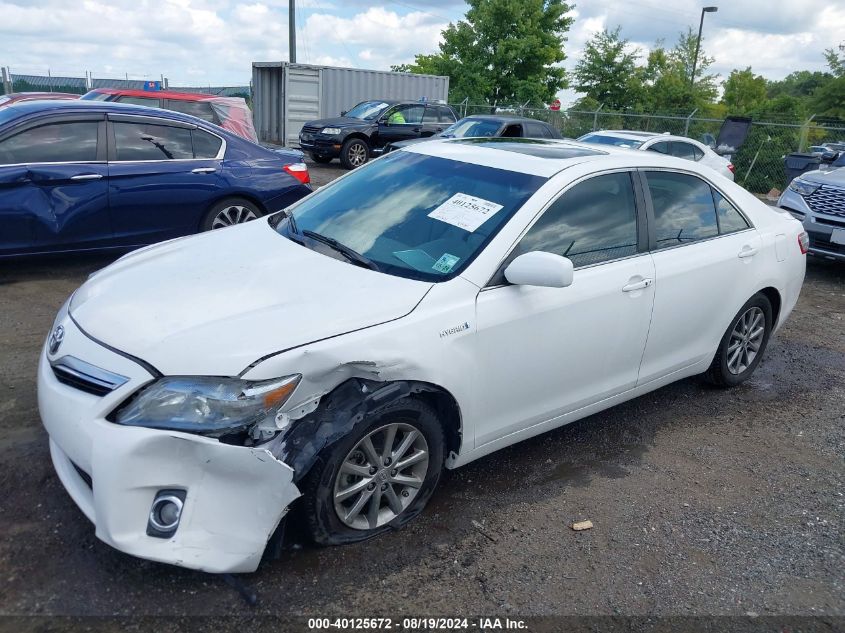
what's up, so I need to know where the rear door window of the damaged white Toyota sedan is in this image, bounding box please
[646,171,719,249]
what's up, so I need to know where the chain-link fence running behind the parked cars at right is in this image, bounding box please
[452,102,845,194]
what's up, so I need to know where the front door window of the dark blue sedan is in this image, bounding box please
[0,121,99,165]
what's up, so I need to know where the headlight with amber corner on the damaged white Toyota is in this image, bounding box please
[114,374,301,436]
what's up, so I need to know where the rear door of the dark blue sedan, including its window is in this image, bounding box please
[108,114,229,246]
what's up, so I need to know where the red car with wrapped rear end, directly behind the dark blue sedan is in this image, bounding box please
[81,88,258,143]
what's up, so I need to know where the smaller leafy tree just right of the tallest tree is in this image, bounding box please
[573,26,642,110]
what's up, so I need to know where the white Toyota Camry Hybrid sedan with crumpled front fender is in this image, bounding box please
[38,139,807,572]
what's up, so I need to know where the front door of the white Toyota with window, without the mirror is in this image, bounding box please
[475,172,654,446]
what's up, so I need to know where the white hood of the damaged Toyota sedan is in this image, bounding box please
[70,220,432,376]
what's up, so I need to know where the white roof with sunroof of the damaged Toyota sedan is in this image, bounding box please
[400,137,715,178]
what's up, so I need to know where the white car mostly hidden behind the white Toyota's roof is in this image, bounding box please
[578,130,734,180]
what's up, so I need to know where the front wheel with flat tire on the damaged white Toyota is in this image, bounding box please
[302,399,444,545]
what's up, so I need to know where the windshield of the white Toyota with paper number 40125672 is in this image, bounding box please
[276,152,546,281]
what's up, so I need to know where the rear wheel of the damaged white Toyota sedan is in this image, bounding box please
[705,293,772,387]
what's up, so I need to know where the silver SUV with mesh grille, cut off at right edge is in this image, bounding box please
[778,167,845,261]
